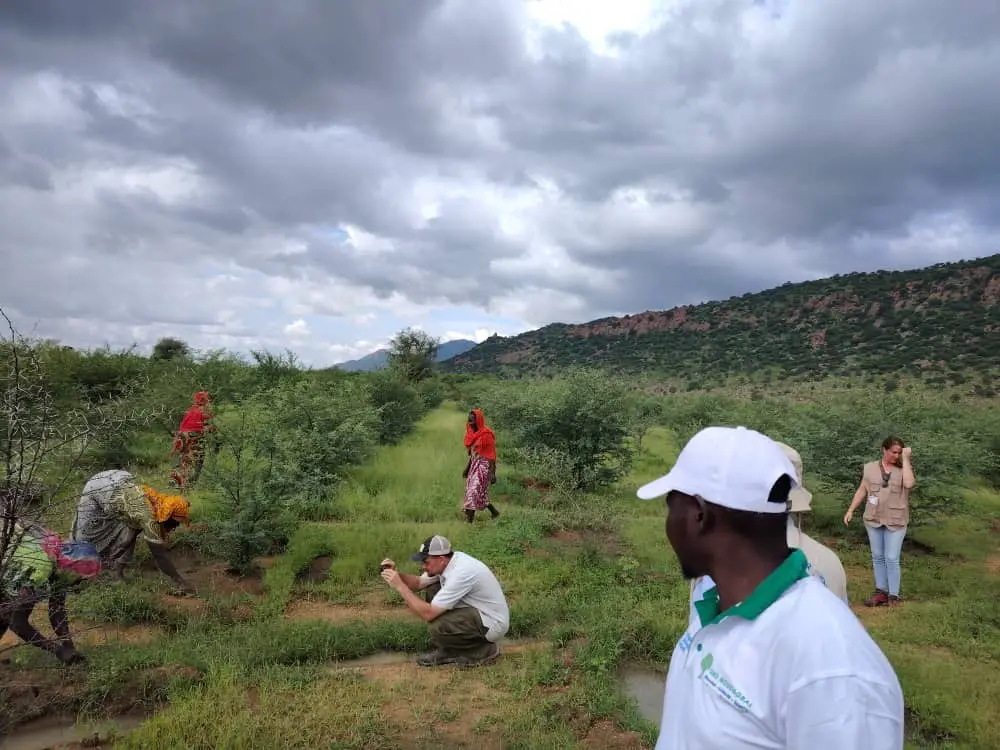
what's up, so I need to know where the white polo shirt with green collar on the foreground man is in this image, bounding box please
[656,550,903,750]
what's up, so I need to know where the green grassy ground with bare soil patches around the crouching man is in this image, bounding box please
[0,406,1000,748]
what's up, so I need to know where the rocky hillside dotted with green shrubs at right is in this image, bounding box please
[446,254,1000,383]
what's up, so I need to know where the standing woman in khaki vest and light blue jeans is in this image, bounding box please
[844,435,917,607]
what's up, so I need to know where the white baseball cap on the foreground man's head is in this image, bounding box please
[636,427,799,513]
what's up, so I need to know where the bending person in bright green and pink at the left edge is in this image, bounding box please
[0,523,101,664]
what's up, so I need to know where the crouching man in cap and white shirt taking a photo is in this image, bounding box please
[382,536,510,667]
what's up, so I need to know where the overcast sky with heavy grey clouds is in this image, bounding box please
[0,0,1000,366]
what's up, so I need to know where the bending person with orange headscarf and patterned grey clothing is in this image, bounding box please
[70,469,194,594]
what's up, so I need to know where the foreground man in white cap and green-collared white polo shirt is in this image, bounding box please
[637,427,903,750]
